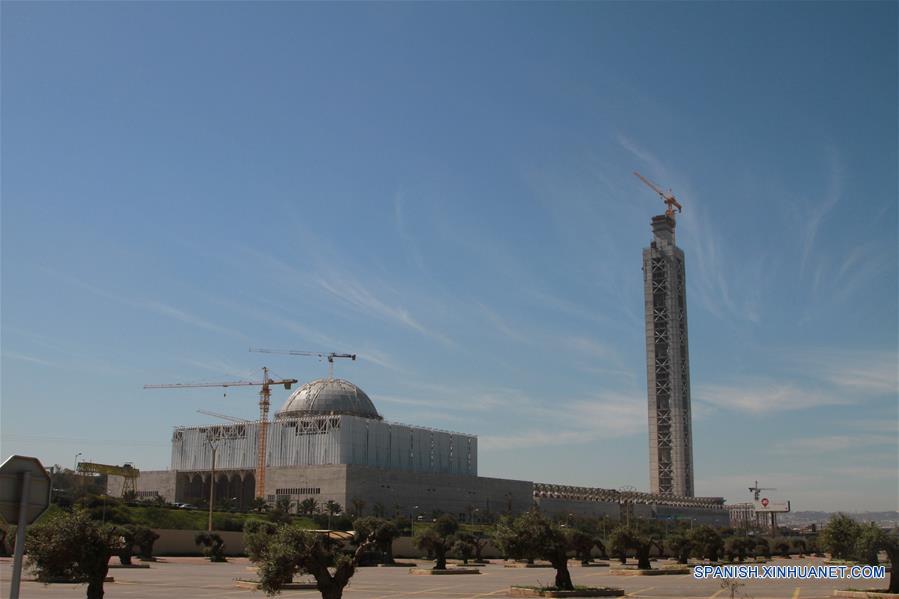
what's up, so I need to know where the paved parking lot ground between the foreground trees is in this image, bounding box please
[0,557,886,599]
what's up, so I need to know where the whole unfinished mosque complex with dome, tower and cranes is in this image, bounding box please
[91,173,789,527]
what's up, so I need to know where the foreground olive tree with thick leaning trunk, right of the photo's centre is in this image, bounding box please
[497,509,574,591]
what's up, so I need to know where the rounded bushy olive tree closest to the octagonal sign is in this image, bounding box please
[27,509,119,599]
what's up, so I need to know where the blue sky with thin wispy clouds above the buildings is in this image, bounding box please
[0,2,899,510]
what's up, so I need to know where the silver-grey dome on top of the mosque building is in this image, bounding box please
[275,379,383,420]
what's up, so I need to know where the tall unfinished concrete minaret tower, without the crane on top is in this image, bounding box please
[643,211,693,497]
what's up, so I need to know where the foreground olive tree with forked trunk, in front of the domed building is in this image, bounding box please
[259,526,372,599]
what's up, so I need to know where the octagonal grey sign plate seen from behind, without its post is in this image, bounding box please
[0,455,50,524]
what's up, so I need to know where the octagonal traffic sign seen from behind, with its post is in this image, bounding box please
[0,455,50,599]
